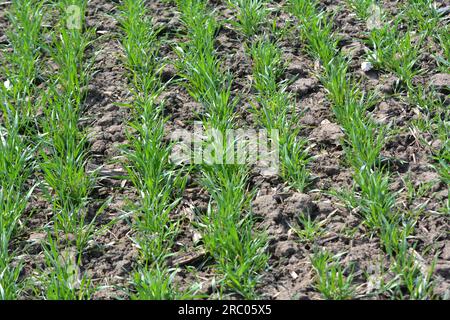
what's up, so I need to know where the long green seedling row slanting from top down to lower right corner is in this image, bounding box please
[288,0,432,298]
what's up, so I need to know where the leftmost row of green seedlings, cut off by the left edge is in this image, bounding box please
[0,0,43,300]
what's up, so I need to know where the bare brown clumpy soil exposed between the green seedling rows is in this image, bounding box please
[4,0,450,299]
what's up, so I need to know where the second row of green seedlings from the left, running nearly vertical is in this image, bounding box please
[35,0,97,300]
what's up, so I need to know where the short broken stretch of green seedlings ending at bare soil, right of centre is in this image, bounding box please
[249,40,311,192]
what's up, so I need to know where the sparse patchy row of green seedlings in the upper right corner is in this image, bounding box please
[356,0,450,213]
